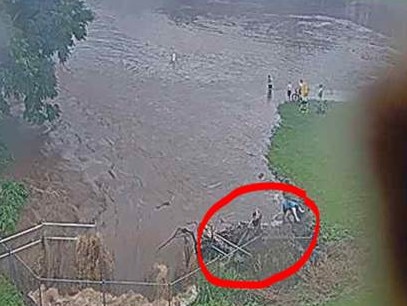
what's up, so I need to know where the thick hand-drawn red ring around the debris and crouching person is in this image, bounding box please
[197,182,320,289]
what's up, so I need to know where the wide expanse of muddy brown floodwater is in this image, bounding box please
[3,0,404,280]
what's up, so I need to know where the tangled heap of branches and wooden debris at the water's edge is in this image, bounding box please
[158,204,324,274]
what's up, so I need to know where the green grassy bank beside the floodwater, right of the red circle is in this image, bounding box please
[267,102,381,306]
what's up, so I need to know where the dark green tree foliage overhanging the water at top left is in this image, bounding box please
[0,0,93,124]
